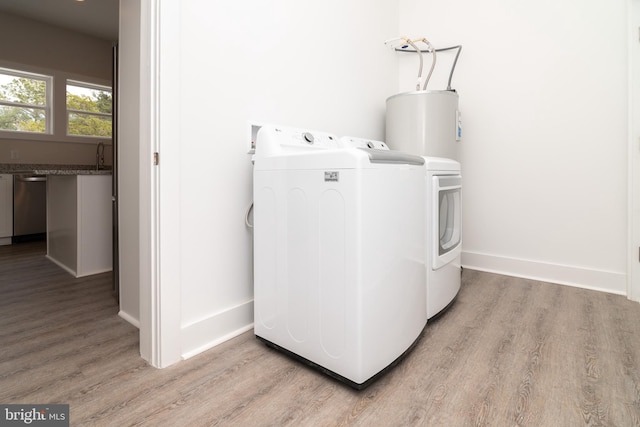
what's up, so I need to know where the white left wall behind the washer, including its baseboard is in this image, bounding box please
[151,0,398,362]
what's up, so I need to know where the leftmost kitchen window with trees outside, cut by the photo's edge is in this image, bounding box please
[0,68,53,134]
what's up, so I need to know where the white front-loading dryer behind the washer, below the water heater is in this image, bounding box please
[424,157,462,319]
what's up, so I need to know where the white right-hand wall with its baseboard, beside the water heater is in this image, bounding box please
[399,0,629,293]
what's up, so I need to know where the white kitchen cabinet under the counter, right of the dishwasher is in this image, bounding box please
[47,175,113,277]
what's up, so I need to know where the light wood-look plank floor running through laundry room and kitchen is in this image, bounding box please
[0,243,640,427]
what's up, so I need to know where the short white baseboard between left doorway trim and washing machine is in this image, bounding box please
[182,301,253,359]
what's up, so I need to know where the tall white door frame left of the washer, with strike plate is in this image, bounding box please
[140,0,182,368]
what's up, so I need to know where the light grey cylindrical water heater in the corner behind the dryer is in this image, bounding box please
[385,90,462,161]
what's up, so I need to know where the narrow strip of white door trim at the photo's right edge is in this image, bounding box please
[627,0,640,302]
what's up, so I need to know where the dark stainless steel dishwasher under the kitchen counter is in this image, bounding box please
[13,174,47,242]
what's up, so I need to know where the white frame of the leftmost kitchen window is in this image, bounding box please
[0,64,54,138]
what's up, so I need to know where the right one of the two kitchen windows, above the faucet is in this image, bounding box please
[67,80,113,138]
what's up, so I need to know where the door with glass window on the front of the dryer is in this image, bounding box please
[432,176,462,269]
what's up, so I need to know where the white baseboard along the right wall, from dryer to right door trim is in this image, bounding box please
[462,251,627,296]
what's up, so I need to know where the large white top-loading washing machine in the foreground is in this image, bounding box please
[253,126,427,389]
